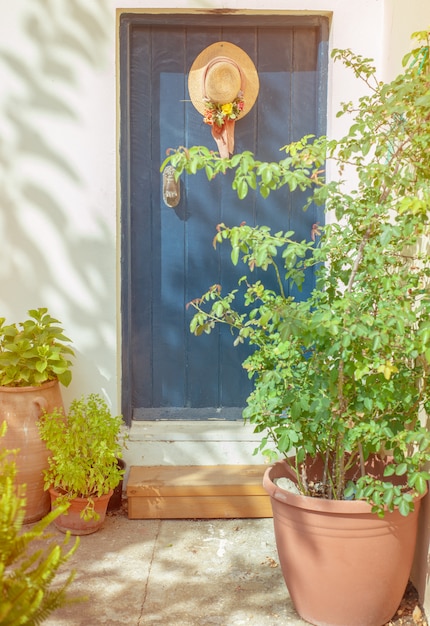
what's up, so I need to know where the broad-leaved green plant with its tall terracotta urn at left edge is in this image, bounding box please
[0,308,73,523]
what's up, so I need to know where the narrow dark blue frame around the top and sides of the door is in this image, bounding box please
[118,10,329,426]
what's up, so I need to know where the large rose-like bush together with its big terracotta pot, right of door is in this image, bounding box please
[161,32,430,626]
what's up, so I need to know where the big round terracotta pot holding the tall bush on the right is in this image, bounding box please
[263,461,420,626]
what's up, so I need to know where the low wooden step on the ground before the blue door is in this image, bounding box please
[127,465,272,519]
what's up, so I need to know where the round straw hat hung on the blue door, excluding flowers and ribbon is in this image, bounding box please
[188,41,260,118]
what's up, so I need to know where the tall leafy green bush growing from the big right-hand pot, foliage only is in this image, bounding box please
[163,32,430,516]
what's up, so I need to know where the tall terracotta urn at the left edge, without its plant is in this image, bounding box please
[0,380,63,524]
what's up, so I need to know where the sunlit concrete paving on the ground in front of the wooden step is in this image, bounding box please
[44,502,306,626]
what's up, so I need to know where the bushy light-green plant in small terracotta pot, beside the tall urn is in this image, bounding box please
[39,394,124,535]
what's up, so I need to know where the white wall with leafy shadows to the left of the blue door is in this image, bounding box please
[0,0,116,394]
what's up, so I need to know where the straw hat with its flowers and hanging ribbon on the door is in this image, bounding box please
[188,41,259,157]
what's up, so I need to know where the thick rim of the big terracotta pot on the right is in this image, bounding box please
[263,460,427,519]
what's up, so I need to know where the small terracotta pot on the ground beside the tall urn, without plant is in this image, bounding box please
[49,488,113,535]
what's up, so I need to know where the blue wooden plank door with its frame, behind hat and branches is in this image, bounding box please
[120,14,327,419]
